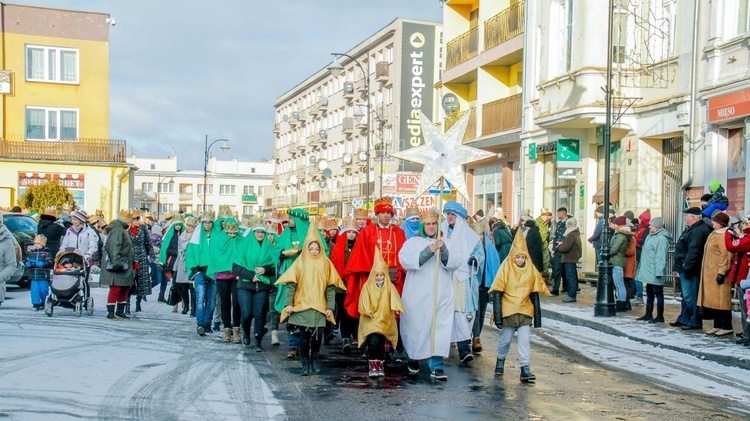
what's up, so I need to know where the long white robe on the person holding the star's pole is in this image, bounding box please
[398,237,462,360]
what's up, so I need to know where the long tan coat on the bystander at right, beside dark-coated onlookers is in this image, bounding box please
[698,228,732,310]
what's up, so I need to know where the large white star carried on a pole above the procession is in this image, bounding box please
[392,112,495,202]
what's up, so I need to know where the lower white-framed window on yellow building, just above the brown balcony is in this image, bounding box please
[26,107,78,140]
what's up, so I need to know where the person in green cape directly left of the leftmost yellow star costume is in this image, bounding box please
[232,221,279,352]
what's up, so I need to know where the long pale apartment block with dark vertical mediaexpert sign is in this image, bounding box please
[274,18,442,216]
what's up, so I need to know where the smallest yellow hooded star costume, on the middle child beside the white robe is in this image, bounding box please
[357,247,404,348]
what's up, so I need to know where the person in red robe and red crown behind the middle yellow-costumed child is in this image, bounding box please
[344,197,406,318]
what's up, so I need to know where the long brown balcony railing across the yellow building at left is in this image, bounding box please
[0,135,127,163]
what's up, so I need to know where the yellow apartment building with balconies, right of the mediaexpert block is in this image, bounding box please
[439,0,527,220]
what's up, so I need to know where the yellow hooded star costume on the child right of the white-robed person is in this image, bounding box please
[489,229,552,324]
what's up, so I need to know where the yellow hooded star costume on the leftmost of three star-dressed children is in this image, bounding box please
[276,218,346,327]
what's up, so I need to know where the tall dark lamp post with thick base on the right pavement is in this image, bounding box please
[594,0,615,317]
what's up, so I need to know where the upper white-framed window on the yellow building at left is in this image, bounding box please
[26,45,78,83]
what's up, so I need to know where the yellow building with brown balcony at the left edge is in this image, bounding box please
[0,3,133,217]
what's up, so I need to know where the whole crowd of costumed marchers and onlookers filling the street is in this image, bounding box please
[0,179,750,381]
